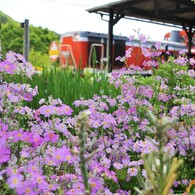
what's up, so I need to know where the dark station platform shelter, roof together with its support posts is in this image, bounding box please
[87,0,195,72]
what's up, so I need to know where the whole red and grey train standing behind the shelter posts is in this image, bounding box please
[59,31,191,69]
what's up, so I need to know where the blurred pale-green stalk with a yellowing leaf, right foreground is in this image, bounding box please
[135,111,183,195]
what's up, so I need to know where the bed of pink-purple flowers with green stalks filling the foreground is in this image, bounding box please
[0,43,195,195]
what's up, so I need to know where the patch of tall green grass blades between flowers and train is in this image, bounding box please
[9,68,119,114]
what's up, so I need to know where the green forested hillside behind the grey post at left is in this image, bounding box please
[0,11,59,66]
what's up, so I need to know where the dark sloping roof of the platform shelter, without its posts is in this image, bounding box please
[87,0,195,29]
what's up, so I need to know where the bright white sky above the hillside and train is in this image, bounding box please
[0,0,181,41]
